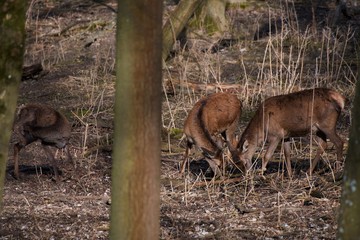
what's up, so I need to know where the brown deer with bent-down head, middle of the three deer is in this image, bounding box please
[180,93,246,175]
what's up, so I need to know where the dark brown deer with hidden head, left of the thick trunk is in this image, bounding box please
[13,104,72,180]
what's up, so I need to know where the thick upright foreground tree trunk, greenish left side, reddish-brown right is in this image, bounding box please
[110,0,162,239]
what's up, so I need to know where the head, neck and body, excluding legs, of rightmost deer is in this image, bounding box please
[238,88,345,163]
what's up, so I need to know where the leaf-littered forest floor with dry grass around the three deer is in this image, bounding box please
[0,0,357,240]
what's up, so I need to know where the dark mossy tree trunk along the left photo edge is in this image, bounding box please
[0,0,27,208]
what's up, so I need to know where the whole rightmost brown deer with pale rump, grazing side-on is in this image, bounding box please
[238,88,345,177]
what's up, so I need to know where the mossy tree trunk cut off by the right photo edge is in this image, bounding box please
[337,71,360,239]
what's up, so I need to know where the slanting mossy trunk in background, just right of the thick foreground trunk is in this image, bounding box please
[162,0,203,61]
